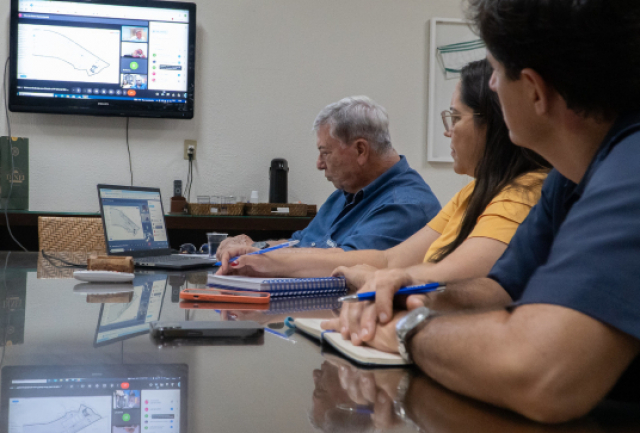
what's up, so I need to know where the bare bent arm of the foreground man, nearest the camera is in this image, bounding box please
[410,304,640,422]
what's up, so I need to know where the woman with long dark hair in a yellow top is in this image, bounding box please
[219,60,550,344]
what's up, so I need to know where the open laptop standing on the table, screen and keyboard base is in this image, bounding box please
[98,185,215,269]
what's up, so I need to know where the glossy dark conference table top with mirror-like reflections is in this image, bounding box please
[0,252,640,433]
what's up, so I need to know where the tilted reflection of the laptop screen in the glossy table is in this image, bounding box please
[93,274,167,347]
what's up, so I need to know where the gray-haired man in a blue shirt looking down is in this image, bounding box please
[217,96,440,257]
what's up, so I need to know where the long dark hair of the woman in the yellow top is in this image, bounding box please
[429,59,551,262]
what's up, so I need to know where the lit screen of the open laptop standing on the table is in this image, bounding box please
[99,187,169,254]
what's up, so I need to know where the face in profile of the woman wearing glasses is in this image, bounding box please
[444,81,486,176]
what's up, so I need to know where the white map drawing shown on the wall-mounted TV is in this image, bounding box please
[18,24,120,83]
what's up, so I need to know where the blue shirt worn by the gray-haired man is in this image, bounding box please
[291,156,440,251]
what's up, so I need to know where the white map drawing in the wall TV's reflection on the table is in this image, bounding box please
[9,396,111,433]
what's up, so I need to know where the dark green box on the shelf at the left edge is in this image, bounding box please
[0,137,29,210]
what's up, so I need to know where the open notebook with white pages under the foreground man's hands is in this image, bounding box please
[294,319,407,367]
